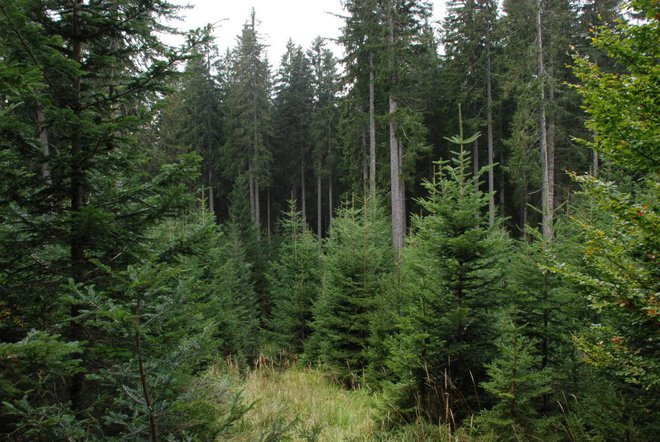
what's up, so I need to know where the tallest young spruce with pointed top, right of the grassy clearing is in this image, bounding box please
[387,115,506,426]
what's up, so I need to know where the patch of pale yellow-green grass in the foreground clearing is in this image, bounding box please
[216,365,472,442]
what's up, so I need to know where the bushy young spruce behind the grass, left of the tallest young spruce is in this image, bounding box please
[306,199,392,386]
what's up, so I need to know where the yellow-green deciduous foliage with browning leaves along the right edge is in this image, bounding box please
[556,1,660,440]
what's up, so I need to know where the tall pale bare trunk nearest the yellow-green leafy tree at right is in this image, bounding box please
[536,0,553,242]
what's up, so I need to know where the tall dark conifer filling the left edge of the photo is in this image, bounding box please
[0,0,203,440]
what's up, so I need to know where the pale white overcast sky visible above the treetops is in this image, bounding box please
[173,0,445,66]
